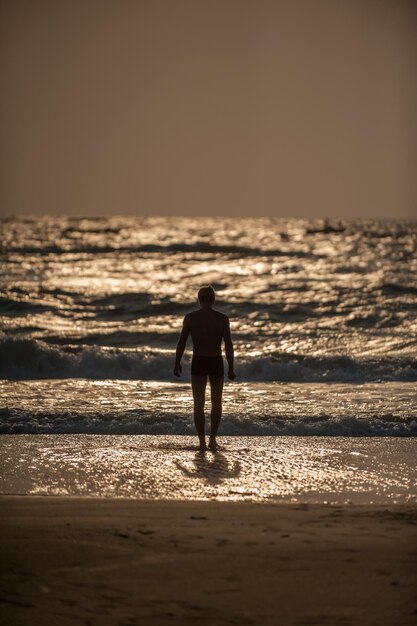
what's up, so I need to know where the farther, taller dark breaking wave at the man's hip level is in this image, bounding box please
[0,338,417,383]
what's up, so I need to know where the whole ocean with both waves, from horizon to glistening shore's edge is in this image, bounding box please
[0,217,417,437]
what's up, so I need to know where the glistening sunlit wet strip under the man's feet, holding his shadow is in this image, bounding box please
[0,435,417,504]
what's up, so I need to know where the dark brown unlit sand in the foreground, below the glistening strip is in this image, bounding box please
[0,496,417,626]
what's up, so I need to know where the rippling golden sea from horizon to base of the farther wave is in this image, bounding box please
[0,217,417,383]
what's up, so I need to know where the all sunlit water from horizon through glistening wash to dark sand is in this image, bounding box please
[0,217,417,501]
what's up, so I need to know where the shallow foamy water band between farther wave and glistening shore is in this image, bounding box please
[0,379,417,437]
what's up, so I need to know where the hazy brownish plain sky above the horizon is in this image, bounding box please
[0,0,417,218]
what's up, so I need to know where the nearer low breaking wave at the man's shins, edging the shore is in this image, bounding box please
[0,409,417,437]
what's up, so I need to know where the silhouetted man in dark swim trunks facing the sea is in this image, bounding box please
[174,285,236,450]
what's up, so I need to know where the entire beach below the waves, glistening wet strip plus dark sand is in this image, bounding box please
[0,435,417,626]
